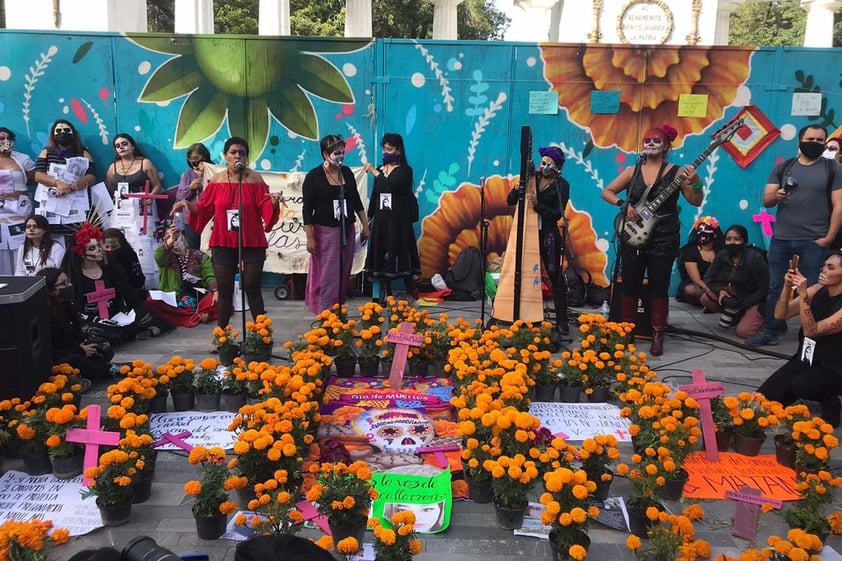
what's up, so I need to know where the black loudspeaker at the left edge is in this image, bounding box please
[0,276,53,399]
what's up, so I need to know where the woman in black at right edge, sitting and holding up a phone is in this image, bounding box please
[757,250,842,427]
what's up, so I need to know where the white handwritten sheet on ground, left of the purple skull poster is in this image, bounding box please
[149,411,236,450]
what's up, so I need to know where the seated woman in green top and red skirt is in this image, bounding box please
[147,223,218,327]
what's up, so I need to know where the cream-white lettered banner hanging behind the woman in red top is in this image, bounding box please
[202,164,369,274]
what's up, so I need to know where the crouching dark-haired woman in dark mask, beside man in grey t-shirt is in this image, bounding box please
[701,224,769,339]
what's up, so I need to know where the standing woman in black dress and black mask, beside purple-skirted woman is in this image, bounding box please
[364,133,421,299]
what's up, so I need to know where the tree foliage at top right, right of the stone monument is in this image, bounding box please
[728,0,842,47]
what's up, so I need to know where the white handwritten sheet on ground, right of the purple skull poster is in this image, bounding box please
[529,401,631,442]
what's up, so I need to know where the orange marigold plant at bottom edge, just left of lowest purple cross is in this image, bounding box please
[626,504,710,561]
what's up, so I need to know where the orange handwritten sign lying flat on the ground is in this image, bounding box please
[683,452,801,501]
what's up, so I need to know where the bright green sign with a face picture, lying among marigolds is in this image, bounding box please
[371,470,453,534]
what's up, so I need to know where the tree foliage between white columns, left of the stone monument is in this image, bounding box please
[147,0,511,40]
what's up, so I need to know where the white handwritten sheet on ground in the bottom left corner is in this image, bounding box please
[0,471,102,536]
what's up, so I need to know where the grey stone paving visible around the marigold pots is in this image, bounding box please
[21,296,842,561]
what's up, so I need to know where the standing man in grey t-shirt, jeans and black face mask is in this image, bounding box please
[746,124,842,347]
